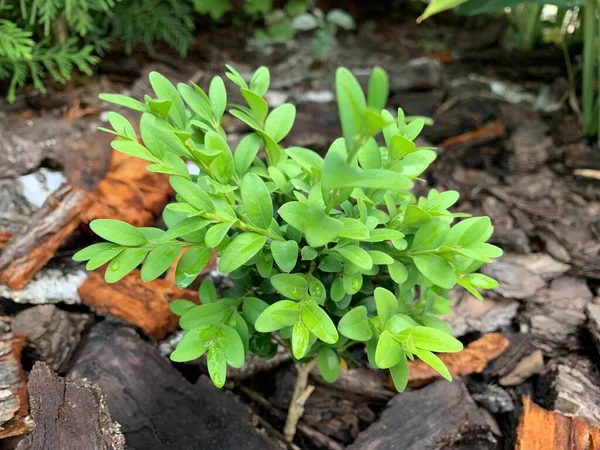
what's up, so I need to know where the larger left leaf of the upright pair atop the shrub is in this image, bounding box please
[335,67,367,148]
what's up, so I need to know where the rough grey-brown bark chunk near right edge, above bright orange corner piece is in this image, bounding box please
[525,277,592,355]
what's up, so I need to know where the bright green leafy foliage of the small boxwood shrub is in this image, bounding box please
[74,66,502,391]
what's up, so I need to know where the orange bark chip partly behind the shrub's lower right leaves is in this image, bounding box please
[389,333,510,389]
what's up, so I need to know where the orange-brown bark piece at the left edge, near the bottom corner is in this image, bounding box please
[0,332,30,439]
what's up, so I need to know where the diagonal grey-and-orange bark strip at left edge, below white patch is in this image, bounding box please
[0,185,89,290]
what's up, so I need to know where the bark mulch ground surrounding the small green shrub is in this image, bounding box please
[0,7,600,450]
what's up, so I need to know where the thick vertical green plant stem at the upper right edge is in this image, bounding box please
[581,0,596,135]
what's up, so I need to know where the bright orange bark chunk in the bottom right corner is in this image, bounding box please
[515,397,600,450]
